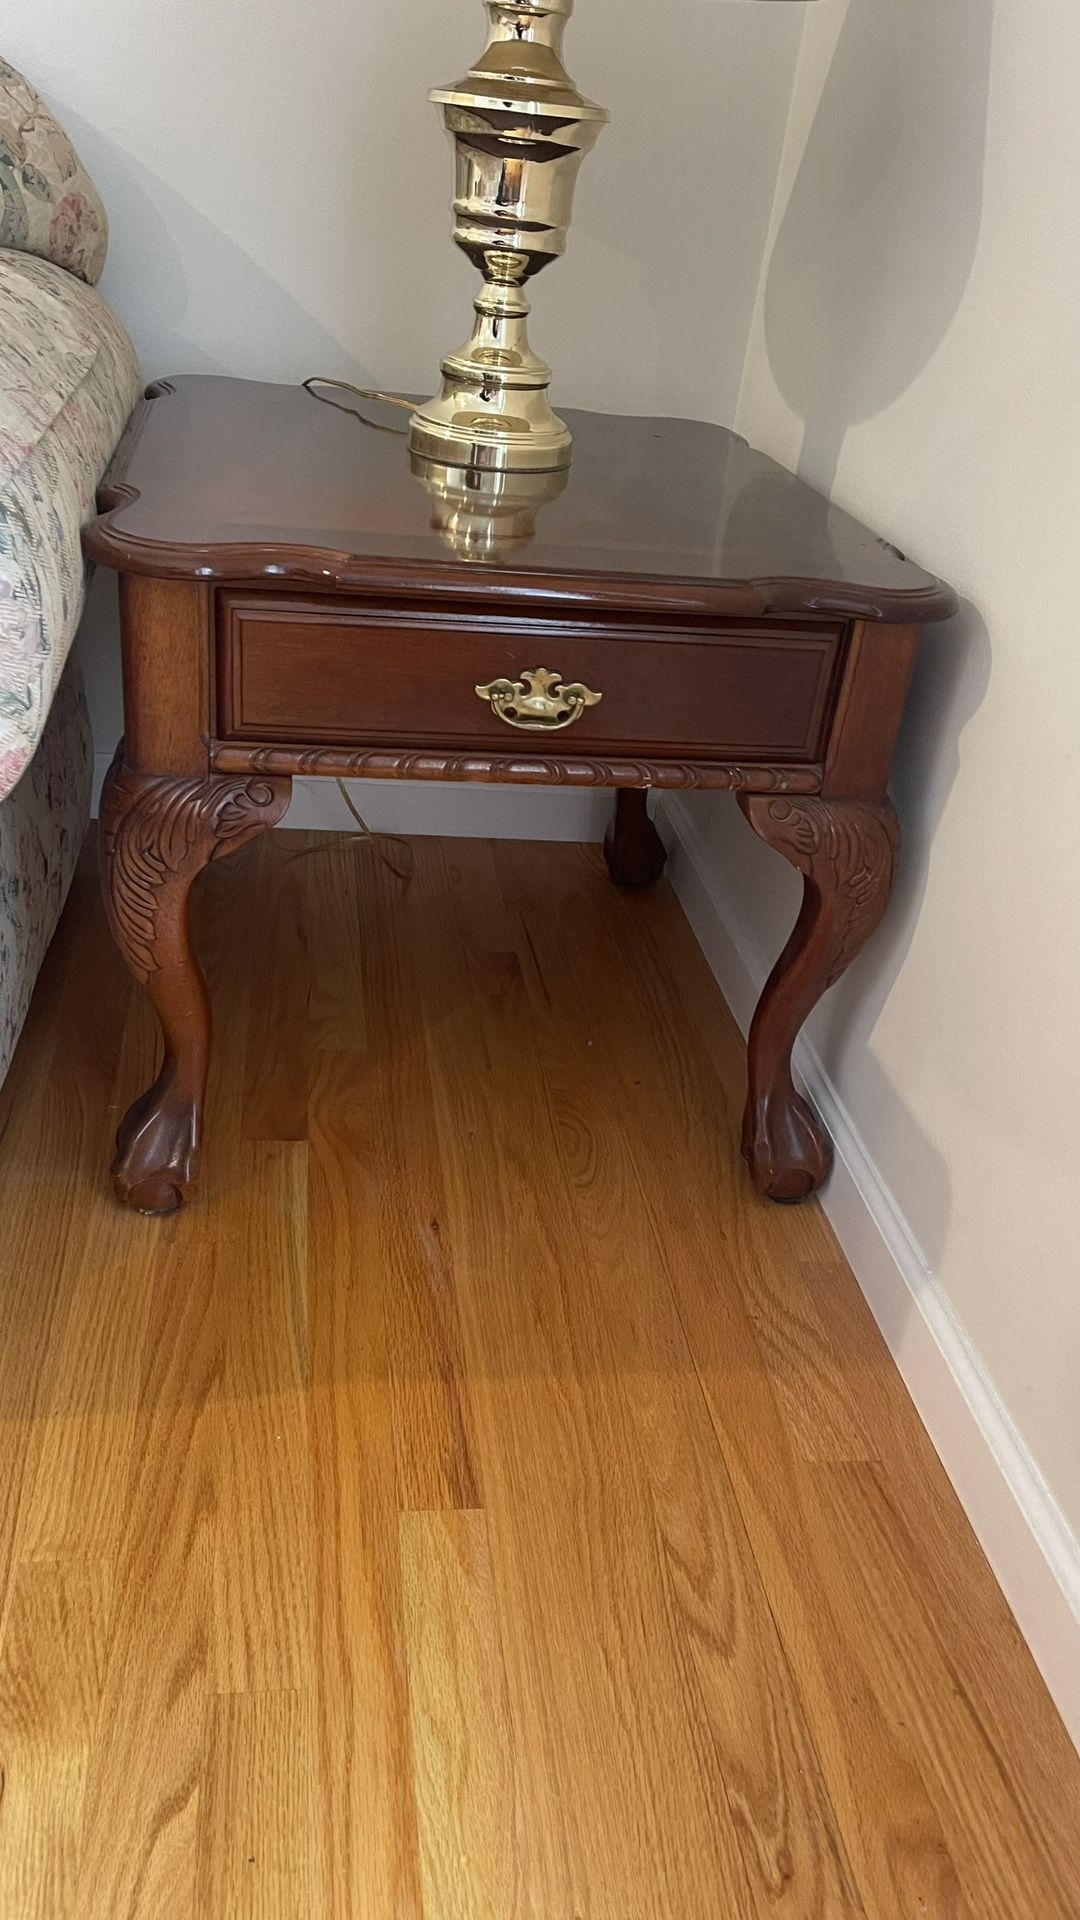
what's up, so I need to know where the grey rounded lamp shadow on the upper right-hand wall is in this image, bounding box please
[765,0,992,492]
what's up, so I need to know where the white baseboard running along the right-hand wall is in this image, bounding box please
[657,797,1080,1747]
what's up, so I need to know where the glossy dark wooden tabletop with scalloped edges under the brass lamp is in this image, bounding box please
[85,374,955,622]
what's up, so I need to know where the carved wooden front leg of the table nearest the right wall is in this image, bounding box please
[740,793,899,1202]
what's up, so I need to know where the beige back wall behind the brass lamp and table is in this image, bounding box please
[8,0,803,787]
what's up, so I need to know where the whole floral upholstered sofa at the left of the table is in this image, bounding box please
[0,60,138,1081]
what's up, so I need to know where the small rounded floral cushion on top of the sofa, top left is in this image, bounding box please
[0,60,108,284]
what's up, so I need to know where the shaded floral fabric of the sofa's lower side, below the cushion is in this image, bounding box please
[0,660,94,1081]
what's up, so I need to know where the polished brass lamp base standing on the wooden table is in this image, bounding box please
[409,0,607,472]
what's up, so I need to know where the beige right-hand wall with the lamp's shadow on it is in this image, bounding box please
[684,0,1080,1530]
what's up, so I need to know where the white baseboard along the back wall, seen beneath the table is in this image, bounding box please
[94,753,611,841]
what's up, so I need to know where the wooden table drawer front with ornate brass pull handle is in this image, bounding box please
[217,591,844,760]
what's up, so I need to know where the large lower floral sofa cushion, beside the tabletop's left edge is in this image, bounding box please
[0,250,138,799]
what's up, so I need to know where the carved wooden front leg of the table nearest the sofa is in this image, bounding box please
[100,755,292,1213]
